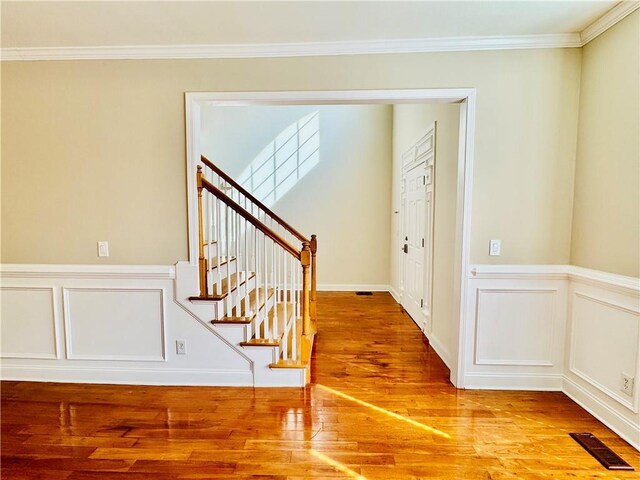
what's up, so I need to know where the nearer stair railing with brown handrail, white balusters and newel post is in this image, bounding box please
[196,166,314,361]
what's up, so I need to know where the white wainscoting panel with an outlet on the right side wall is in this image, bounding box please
[569,291,640,412]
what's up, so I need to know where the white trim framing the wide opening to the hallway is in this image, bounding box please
[185,88,476,388]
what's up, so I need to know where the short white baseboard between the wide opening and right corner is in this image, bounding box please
[464,372,563,392]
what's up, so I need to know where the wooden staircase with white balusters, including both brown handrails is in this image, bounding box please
[188,156,317,385]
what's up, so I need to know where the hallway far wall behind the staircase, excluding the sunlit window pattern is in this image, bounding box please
[201,105,392,286]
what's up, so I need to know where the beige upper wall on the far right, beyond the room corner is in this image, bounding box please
[571,11,640,277]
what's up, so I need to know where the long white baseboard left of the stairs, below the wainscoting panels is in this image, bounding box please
[1,365,253,387]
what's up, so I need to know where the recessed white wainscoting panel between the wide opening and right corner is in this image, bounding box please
[475,288,558,366]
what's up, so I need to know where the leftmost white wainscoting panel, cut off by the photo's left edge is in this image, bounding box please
[0,285,58,359]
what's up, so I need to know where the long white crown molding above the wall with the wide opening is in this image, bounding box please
[0,33,581,61]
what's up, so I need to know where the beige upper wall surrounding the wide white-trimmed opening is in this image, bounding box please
[2,49,581,264]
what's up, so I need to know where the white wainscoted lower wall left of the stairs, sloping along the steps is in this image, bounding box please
[0,265,254,386]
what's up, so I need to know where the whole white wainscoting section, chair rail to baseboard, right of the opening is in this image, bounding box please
[463,265,568,390]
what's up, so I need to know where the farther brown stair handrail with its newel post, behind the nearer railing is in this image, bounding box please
[200,155,318,322]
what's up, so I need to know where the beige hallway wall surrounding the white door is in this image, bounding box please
[391,104,460,352]
